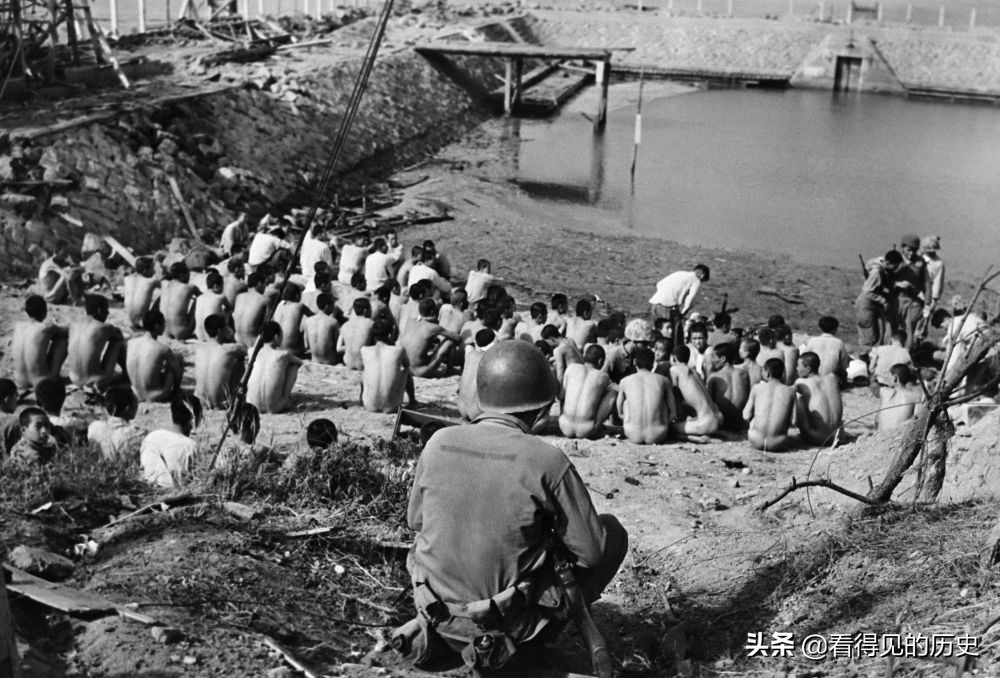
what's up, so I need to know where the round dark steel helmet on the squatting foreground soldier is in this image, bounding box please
[476,339,558,414]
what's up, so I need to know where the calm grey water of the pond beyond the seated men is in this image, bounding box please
[512,90,1000,278]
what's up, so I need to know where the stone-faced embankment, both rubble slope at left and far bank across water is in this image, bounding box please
[0,10,1000,276]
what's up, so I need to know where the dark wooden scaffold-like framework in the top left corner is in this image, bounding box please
[0,0,129,88]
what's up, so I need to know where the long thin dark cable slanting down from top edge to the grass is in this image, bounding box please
[209,0,395,469]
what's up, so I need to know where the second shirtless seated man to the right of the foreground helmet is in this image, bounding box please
[616,347,677,445]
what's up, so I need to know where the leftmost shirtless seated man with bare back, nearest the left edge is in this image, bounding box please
[10,294,69,388]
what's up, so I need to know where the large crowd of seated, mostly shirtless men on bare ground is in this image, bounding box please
[0,217,944,484]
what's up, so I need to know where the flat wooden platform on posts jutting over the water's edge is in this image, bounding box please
[414,40,635,131]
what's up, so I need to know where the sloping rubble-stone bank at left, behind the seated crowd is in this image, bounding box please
[0,41,502,277]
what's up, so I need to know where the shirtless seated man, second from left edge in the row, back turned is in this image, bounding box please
[67,294,126,391]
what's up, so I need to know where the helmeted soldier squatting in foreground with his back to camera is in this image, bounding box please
[394,340,628,669]
